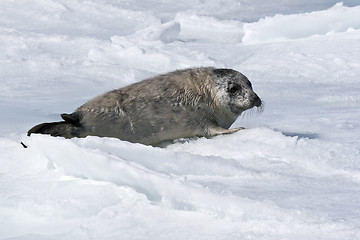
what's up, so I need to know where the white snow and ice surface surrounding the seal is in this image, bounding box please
[0,0,360,240]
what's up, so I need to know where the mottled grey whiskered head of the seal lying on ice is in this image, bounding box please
[213,69,262,116]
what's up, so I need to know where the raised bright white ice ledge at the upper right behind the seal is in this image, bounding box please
[242,3,360,43]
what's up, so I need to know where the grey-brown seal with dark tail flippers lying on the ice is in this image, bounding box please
[28,67,262,145]
